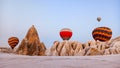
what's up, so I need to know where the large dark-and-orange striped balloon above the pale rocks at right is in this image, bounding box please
[92,27,112,42]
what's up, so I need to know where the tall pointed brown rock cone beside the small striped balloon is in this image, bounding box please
[16,25,46,56]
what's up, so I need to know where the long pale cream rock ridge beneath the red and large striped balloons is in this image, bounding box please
[46,37,120,56]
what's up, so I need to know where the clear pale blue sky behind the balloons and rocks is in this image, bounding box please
[0,0,120,47]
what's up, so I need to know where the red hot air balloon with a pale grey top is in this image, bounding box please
[60,28,72,40]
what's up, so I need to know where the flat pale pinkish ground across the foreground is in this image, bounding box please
[0,53,120,68]
